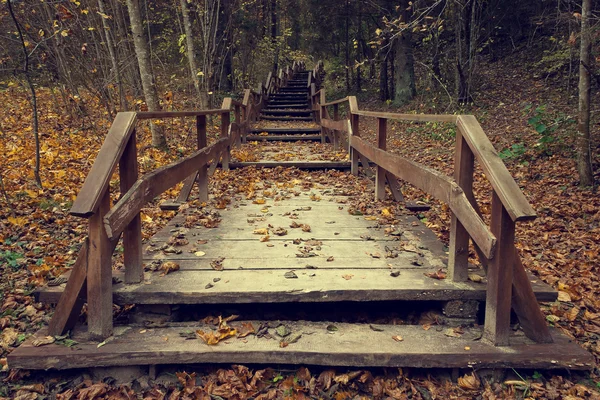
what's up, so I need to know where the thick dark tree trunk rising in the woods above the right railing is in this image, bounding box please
[394,0,417,104]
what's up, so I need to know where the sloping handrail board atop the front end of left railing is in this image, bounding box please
[70,112,137,218]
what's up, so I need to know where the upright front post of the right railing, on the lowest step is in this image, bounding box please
[485,192,516,346]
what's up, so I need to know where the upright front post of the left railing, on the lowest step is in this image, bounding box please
[87,190,113,340]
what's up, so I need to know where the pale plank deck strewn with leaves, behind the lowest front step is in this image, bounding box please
[38,188,556,304]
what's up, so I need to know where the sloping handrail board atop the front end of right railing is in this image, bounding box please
[457,115,537,221]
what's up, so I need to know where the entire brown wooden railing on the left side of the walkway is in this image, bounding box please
[49,63,304,339]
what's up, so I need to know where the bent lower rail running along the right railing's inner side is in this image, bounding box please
[351,136,496,258]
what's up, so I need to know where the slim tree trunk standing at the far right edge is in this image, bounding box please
[577,0,594,186]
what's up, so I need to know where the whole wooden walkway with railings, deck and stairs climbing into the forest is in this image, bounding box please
[8,63,593,369]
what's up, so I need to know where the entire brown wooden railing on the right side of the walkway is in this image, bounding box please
[311,89,552,346]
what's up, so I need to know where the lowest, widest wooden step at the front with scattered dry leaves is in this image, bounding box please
[8,321,595,370]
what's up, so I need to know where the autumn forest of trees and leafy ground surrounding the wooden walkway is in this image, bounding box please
[0,0,600,396]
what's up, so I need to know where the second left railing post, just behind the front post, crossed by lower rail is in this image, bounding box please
[119,130,144,284]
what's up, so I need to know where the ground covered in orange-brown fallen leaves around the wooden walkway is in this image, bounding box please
[0,46,600,400]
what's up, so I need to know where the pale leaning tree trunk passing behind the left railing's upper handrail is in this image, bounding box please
[127,0,167,147]
